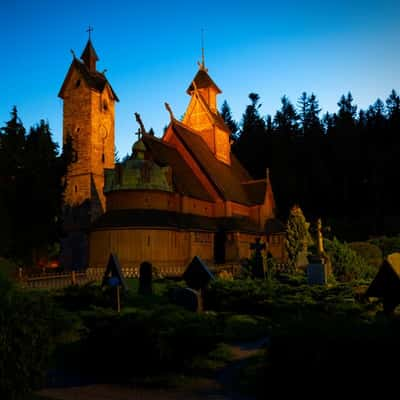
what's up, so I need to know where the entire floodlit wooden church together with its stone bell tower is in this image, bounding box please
[59,39,283,270]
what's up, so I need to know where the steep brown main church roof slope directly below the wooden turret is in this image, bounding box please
[172,121,266,205]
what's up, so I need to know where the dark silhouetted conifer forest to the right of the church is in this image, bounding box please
[220,90,400,240]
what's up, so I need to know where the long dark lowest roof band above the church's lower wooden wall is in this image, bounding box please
[92,209,260,233]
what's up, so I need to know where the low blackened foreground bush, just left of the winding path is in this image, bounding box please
[82,306,221,382]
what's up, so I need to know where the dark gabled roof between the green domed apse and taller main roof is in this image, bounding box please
[142,134,213,201]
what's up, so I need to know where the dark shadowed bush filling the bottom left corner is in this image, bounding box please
[0,270,54,400]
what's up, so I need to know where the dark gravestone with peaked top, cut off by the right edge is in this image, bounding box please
[365,253,400,314]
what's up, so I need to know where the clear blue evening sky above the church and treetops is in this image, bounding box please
[0,0,400,156]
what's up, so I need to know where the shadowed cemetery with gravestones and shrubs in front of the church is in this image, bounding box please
[0,228,400,399]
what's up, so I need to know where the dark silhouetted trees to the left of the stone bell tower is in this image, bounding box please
[0,107,72,265]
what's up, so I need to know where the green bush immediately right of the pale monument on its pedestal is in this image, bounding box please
[324,238,376,282]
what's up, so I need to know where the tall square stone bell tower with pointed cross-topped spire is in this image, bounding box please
[58,32,118,268]
